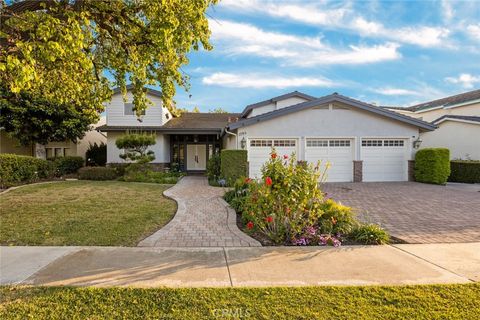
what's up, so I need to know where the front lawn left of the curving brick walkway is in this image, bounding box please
[0,181,176,246]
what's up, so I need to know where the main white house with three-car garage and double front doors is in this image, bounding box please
[98,90,435,181]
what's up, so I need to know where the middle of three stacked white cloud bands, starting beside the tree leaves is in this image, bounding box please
[210,20,401,66]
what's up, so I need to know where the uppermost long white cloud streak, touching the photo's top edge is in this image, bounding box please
[221,0,453,47]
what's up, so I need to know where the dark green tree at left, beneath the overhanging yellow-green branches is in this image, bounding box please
[0,85,98,145]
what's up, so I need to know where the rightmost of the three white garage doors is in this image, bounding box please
[360,139,407,181]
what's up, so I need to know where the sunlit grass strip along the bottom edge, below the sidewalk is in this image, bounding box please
[0,284,480,319]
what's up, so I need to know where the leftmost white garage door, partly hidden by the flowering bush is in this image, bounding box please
[248,139,298,178]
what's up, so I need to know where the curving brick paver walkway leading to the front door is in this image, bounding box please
[138,176,260,247]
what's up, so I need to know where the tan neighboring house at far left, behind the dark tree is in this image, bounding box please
[0,117,107,159]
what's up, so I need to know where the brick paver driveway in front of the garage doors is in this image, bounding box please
[323,182,480,243]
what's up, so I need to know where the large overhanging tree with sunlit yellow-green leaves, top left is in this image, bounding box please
[0,0,217,116]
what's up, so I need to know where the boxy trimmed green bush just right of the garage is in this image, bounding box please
[415,148,450,184]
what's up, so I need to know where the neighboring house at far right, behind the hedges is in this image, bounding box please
[389,90,480,160]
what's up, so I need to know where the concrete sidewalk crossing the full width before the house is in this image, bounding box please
[0,243,480,287]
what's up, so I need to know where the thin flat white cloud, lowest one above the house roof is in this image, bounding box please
[202,72,335,89]
